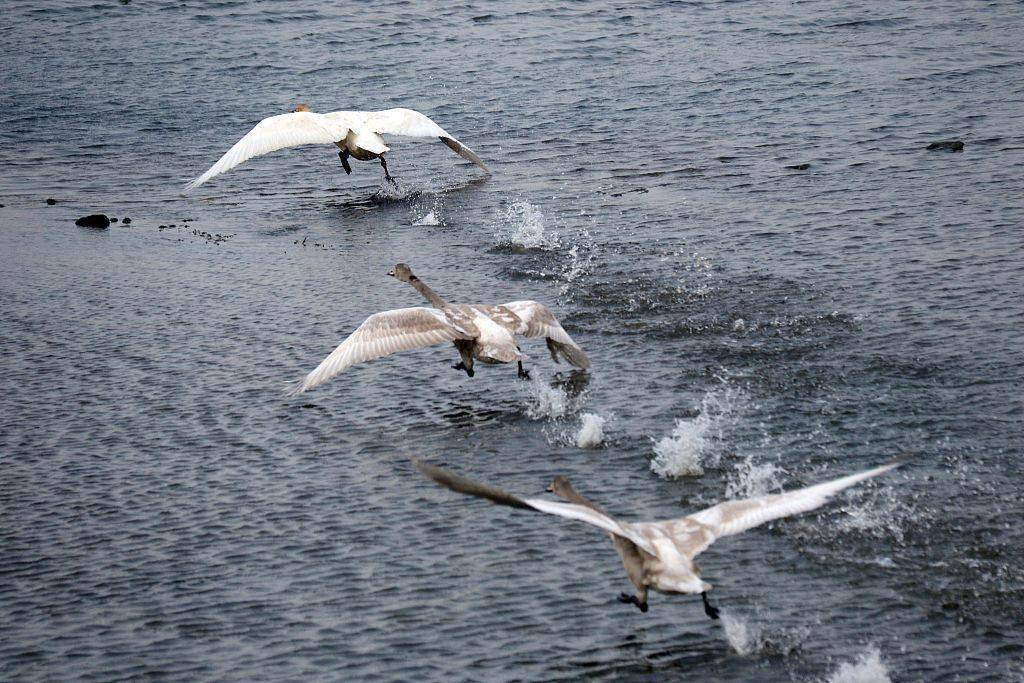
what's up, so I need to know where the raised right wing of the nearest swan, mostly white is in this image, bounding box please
[675,458,907,557]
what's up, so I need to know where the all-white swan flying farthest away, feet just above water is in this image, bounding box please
[185,104,490,193]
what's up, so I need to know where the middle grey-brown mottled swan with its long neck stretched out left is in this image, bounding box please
[291,263,590,395]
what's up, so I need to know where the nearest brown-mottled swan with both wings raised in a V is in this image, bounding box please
[415,458,907,618]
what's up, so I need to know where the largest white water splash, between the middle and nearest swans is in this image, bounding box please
[650,384,742,478]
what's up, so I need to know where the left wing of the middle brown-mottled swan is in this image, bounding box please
[290,306,473,396]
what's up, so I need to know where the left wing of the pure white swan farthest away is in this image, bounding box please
[185,112,349,191]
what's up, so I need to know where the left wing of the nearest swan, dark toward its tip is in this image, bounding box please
[415,460,656,555]
